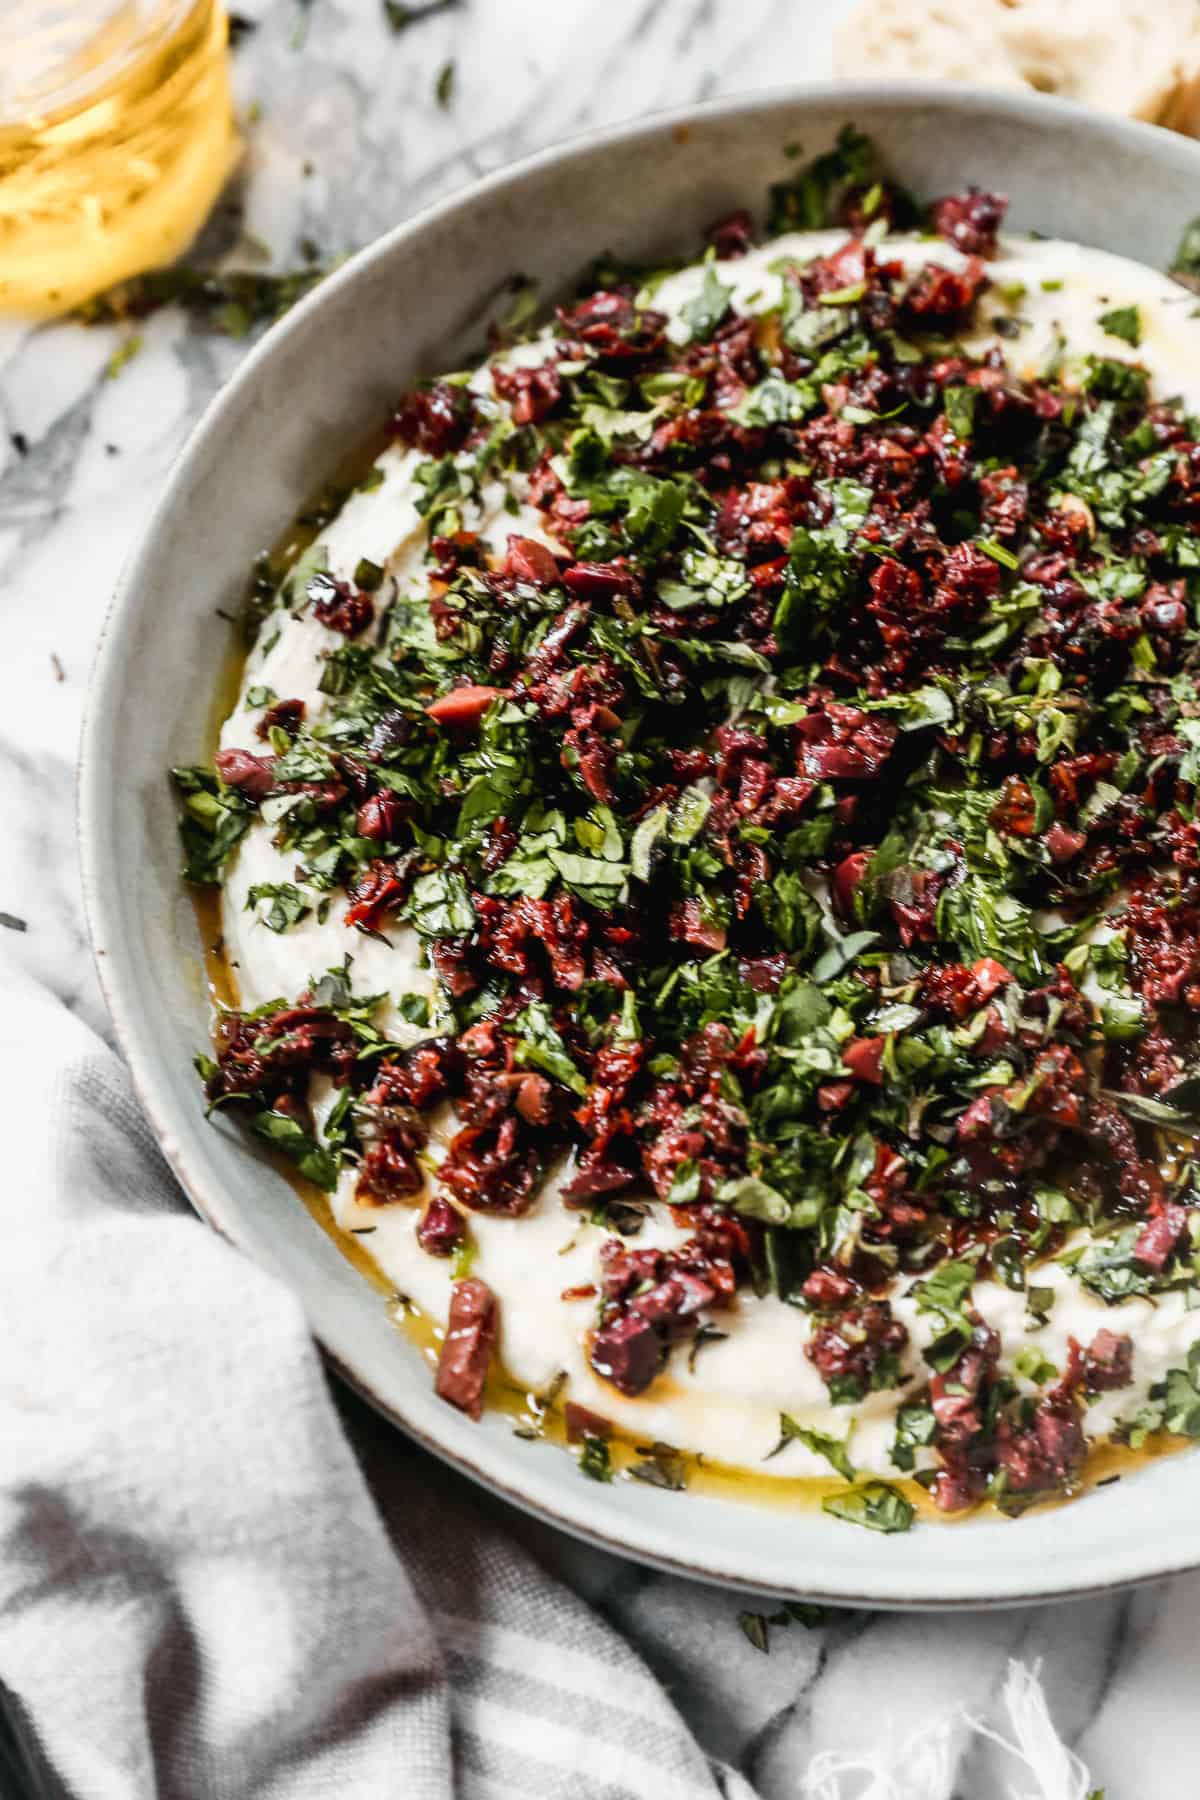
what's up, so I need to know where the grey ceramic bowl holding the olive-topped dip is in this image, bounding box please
[81,85,1200,1607]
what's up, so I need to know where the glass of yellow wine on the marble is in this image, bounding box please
[0,0,239,315]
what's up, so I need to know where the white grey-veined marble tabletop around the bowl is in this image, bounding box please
[0,0,1200,1800]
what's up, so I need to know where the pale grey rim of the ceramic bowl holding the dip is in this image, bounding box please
[76,81,1200,1613]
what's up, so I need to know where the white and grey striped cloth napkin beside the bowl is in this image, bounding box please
[0,970,750,1800]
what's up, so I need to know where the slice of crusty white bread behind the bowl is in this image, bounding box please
[835,0,1200,135]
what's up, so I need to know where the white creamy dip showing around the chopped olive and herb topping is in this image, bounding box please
[221,232,1200,1478]
